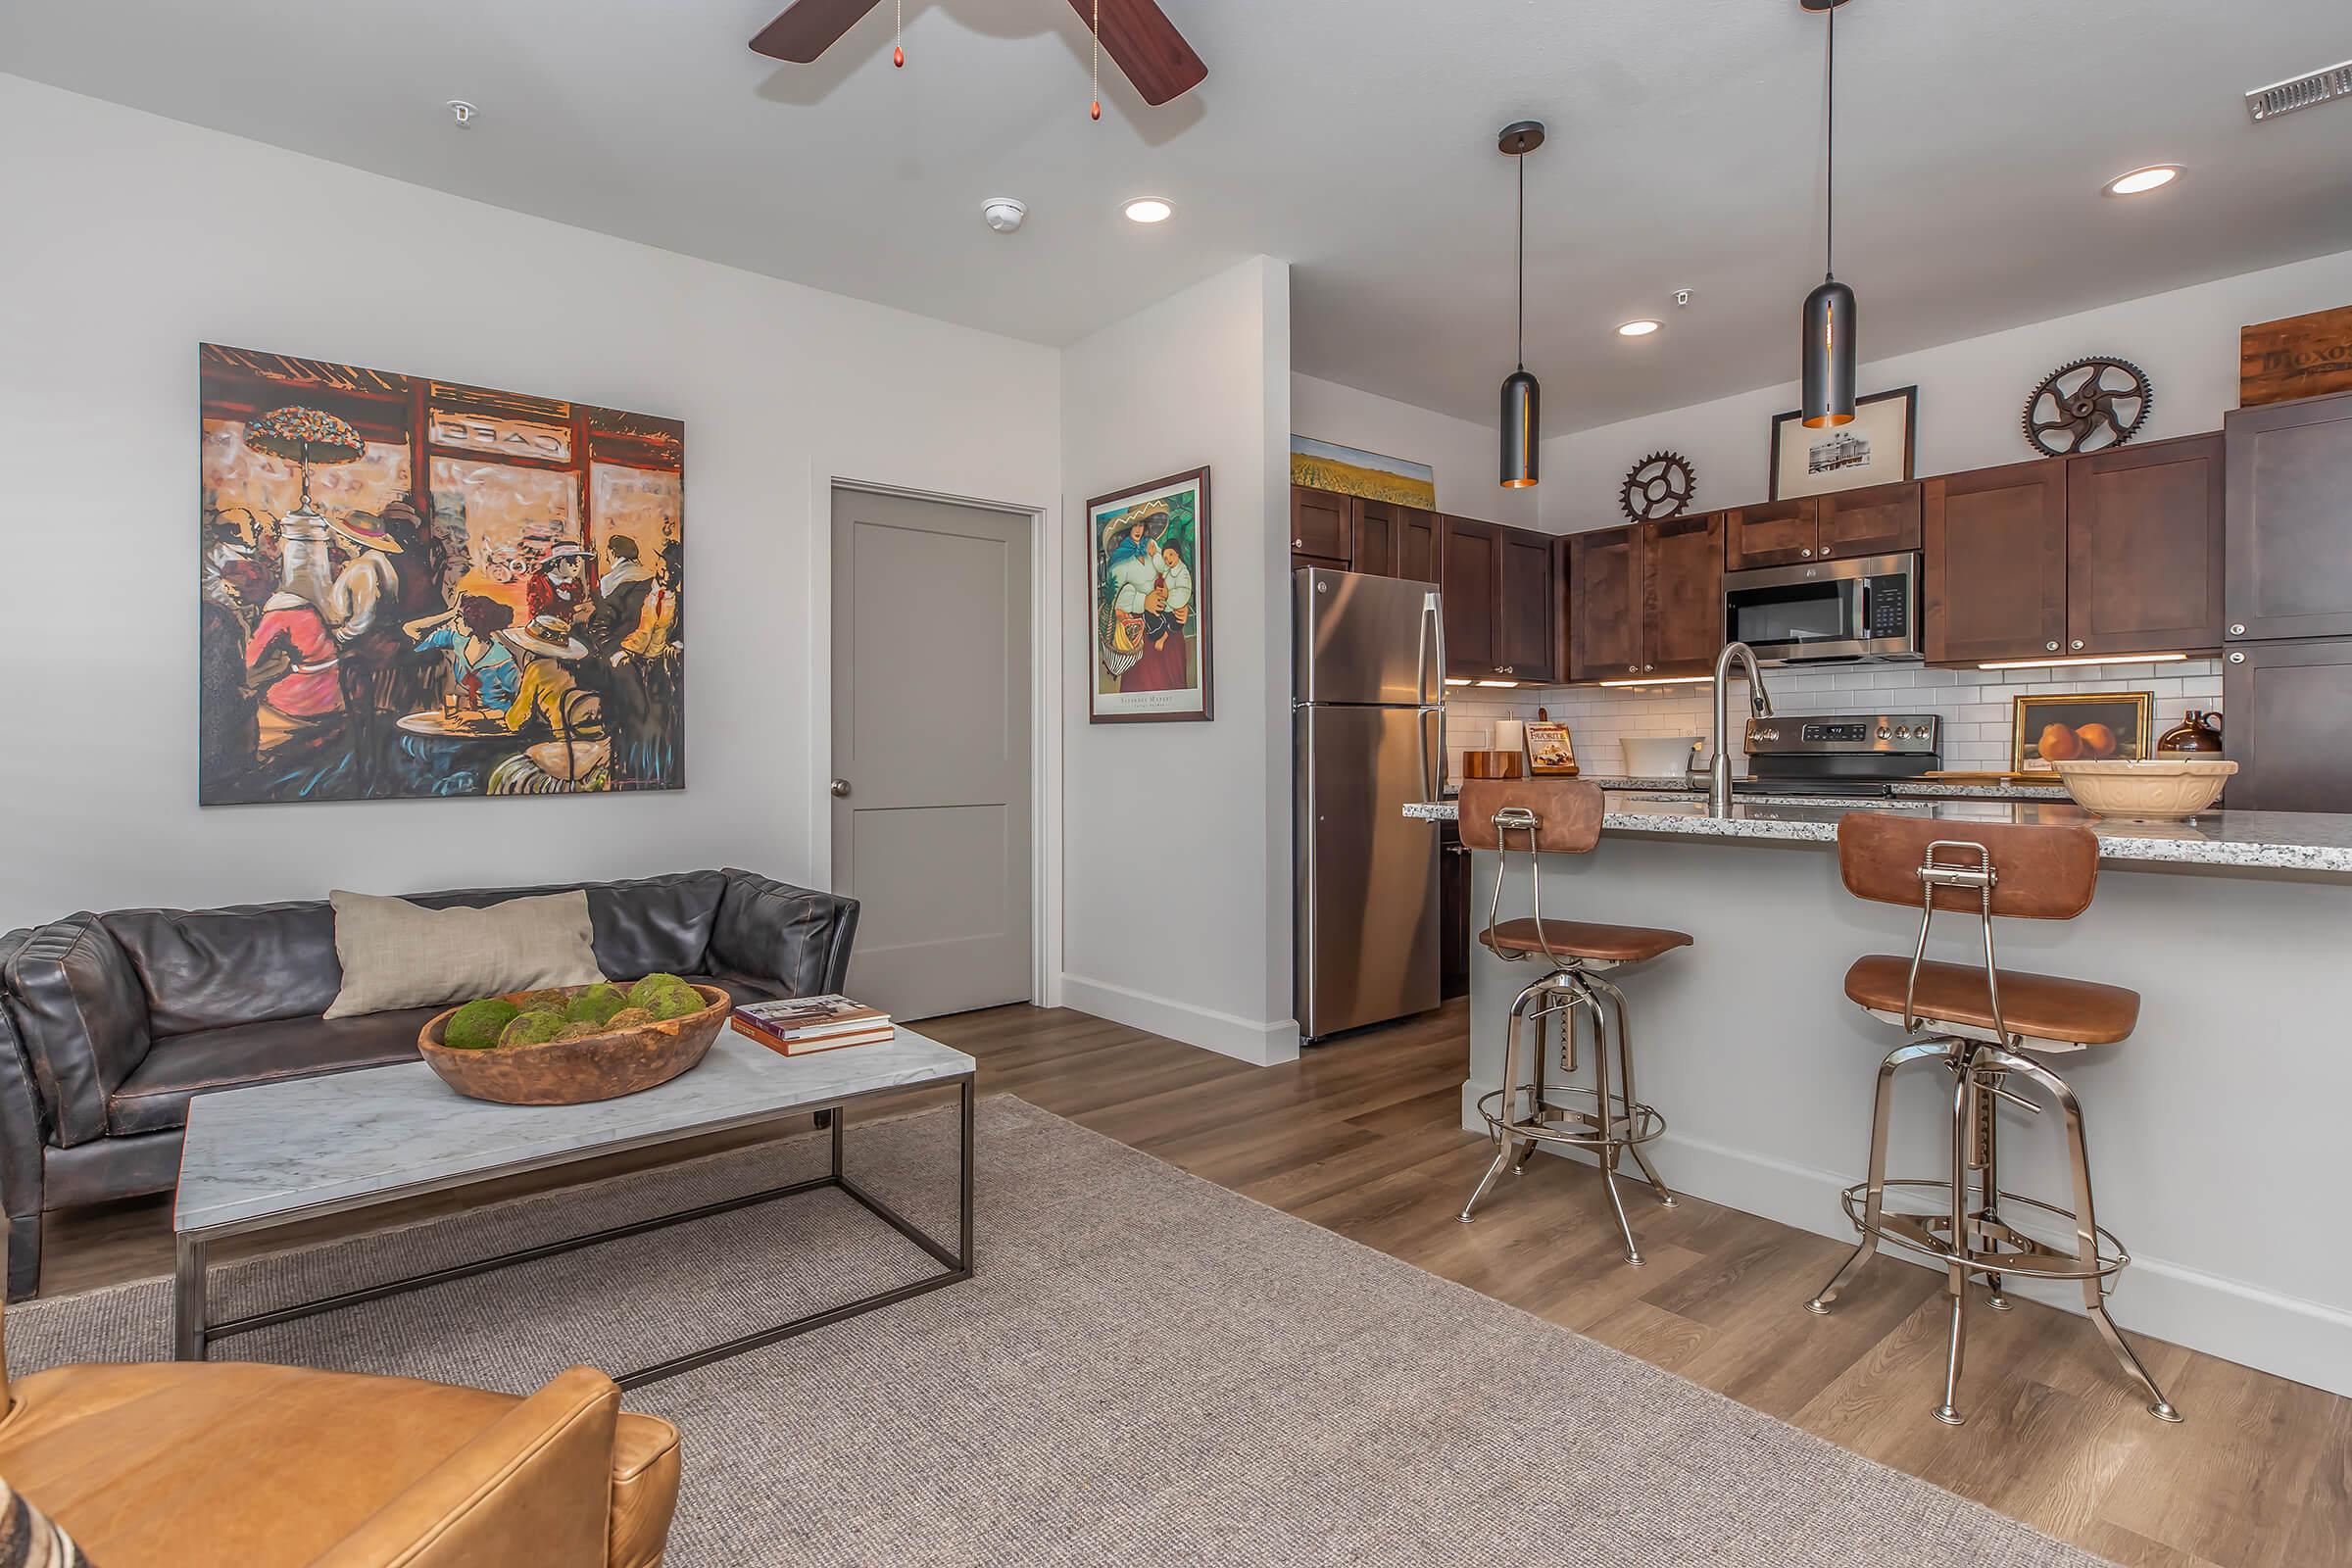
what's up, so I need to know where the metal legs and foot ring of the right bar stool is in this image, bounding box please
[1806,1037,2180,1427]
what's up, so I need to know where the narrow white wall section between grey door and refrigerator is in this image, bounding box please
[1054,256,1298,1062]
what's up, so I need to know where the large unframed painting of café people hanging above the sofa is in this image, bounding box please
[198,343,687,807]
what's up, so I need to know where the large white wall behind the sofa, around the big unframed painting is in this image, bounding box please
[0,75,1058,926]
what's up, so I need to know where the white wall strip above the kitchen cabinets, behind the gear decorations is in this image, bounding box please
[1536,252,2352,534]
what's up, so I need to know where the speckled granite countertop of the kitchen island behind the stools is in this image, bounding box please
[1404,790,2352,877]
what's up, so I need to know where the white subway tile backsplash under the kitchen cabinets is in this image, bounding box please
[1446,659,2221,778]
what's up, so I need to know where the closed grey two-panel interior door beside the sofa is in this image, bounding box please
[833,489,1035,1018]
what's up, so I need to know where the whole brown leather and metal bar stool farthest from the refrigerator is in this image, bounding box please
[1806,811,2180,1427]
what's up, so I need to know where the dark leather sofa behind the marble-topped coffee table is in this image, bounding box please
[0,870,858,1300]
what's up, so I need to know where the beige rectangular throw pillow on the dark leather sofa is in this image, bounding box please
[327,891,605,1018]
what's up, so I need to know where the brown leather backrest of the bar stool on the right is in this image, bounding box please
[1835,808,2098,919]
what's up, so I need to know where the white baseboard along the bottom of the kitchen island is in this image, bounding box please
[1463,1079,2352,1420]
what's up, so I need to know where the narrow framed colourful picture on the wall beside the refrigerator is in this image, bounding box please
[1087,467,1211,724]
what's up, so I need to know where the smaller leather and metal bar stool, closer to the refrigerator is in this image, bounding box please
[1460,778,1691,1267]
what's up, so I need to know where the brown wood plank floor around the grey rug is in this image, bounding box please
[45,1004,2352,1568]
